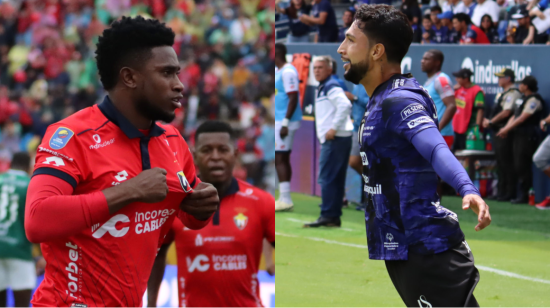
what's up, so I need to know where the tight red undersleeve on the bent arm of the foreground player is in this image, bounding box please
[25,174,110,243]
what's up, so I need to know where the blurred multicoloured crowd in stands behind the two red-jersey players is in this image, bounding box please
[0,0,275,306]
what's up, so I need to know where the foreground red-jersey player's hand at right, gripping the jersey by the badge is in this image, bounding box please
[180,182,220,221]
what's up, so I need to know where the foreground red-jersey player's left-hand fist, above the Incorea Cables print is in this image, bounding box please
[130,167,168,203]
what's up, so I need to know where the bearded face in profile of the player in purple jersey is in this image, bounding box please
[338,21,372,84]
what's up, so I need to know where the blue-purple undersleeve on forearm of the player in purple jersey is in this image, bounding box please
[411,127,479,196]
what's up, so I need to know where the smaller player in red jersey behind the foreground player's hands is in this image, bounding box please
[147,121,275,307]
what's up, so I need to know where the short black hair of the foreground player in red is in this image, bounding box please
[95,16,175,90]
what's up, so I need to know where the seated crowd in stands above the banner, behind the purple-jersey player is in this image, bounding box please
[276,0,550,45]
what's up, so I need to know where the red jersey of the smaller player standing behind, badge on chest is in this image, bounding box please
[165,179,275,307]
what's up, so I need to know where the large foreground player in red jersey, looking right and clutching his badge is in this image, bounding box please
[25,17,219,307]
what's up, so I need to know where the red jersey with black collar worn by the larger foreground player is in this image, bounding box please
[32,97,199,307]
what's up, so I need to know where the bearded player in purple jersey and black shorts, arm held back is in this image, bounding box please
[338,5,491,307]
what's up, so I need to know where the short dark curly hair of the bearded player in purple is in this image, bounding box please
[355,4,413,63]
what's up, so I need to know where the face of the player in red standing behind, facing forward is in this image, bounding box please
[195,133,237,185]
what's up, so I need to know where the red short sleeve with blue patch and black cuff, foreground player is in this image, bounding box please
[33,123,87,189]
